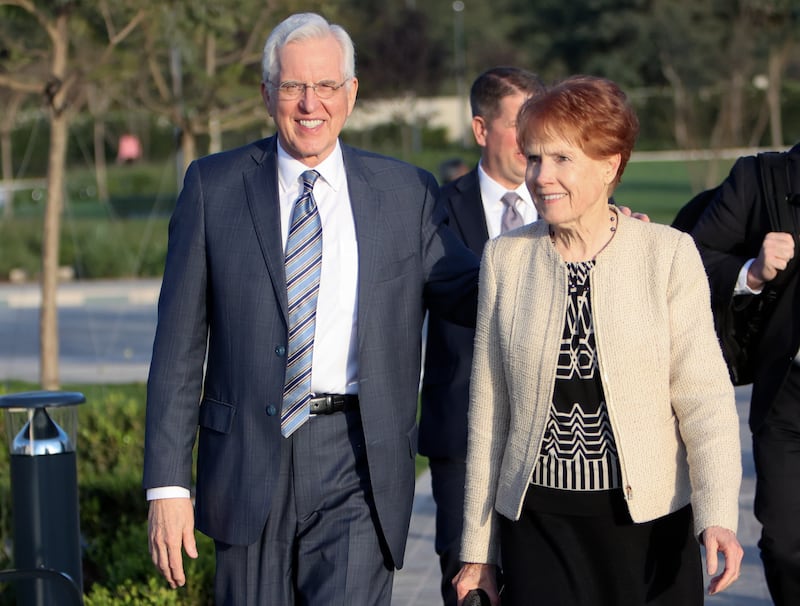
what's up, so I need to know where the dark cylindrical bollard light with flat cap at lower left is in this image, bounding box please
[0,391,86,606]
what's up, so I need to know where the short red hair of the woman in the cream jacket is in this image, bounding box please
[517,76,639,186]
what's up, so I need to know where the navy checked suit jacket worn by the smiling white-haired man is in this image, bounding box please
[143,137,478,567]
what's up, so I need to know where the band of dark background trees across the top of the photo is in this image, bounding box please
[0,0,800,162]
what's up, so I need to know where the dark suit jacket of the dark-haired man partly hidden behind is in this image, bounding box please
[419,168,489,459]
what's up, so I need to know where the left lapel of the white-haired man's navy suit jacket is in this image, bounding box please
[242,137,289,318]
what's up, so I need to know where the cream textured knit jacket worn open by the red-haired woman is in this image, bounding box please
[461,213,742,563]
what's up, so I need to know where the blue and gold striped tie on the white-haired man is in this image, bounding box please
[281,170,322,437]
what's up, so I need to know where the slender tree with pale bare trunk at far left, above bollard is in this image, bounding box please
[0,0,145,389]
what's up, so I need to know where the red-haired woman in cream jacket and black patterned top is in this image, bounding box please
[454,76,743,606]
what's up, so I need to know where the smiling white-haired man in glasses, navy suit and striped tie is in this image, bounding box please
[143,13,478,606]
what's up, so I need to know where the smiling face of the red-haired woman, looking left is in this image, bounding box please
[525,138,620,227]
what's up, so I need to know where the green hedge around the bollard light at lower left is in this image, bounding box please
[0,382,214,606]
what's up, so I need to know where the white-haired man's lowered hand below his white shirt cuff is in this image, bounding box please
[148,498,197,589]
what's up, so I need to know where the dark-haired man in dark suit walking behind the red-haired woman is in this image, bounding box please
[419,67,544,606]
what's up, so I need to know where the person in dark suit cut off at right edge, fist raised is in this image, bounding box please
[692,143,800,606]
